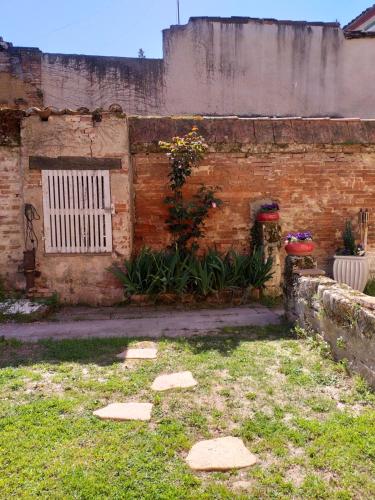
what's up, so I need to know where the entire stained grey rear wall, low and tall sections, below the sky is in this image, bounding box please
[0,17,375,118]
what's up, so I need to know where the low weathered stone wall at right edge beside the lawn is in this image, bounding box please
[286,275,375,388]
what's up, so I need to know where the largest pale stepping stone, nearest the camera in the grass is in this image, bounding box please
[186,436,257,471]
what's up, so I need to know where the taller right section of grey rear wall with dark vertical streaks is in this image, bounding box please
[164,18,375,118]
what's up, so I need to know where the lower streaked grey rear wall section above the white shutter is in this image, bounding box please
[42,54,164,115]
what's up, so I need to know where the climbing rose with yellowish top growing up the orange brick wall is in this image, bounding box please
[159,127,223,250]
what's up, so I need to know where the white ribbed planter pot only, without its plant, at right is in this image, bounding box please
[333,255,370,292]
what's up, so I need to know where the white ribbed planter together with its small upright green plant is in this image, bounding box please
[333,221,370,292]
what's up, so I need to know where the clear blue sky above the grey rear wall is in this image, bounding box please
[0,0,372,57]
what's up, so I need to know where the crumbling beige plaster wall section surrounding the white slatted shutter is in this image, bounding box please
[21,114,133,305]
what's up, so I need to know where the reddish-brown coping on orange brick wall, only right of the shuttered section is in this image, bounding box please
[128,116,375,153]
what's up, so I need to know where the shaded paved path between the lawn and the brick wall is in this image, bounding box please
[0,305,282,341]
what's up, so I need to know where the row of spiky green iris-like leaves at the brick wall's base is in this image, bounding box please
[110,248,272,296]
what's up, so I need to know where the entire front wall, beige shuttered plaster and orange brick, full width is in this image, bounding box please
[0,111,375,304]
